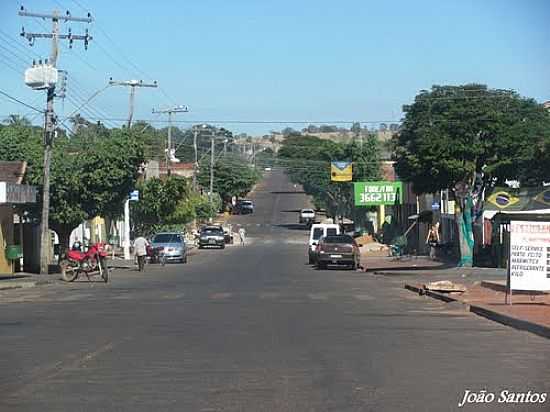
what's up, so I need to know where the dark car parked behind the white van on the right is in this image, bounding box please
[316,235,361,270]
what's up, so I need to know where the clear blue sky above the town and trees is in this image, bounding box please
[0,0,550,134]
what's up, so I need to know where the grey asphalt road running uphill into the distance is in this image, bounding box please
[0,171,550,412]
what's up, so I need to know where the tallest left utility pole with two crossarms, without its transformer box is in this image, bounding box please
[19,6,93,275]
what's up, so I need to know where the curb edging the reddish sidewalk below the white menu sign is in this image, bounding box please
[405,284,550,339]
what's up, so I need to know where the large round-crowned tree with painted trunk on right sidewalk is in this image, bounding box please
[395,84,550,265]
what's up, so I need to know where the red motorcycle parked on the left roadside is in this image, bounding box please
[59,243,109,283]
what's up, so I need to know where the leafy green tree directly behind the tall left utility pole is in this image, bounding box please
[0,119,144,248]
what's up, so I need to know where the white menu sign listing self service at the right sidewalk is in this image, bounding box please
[510,220,550,291]
